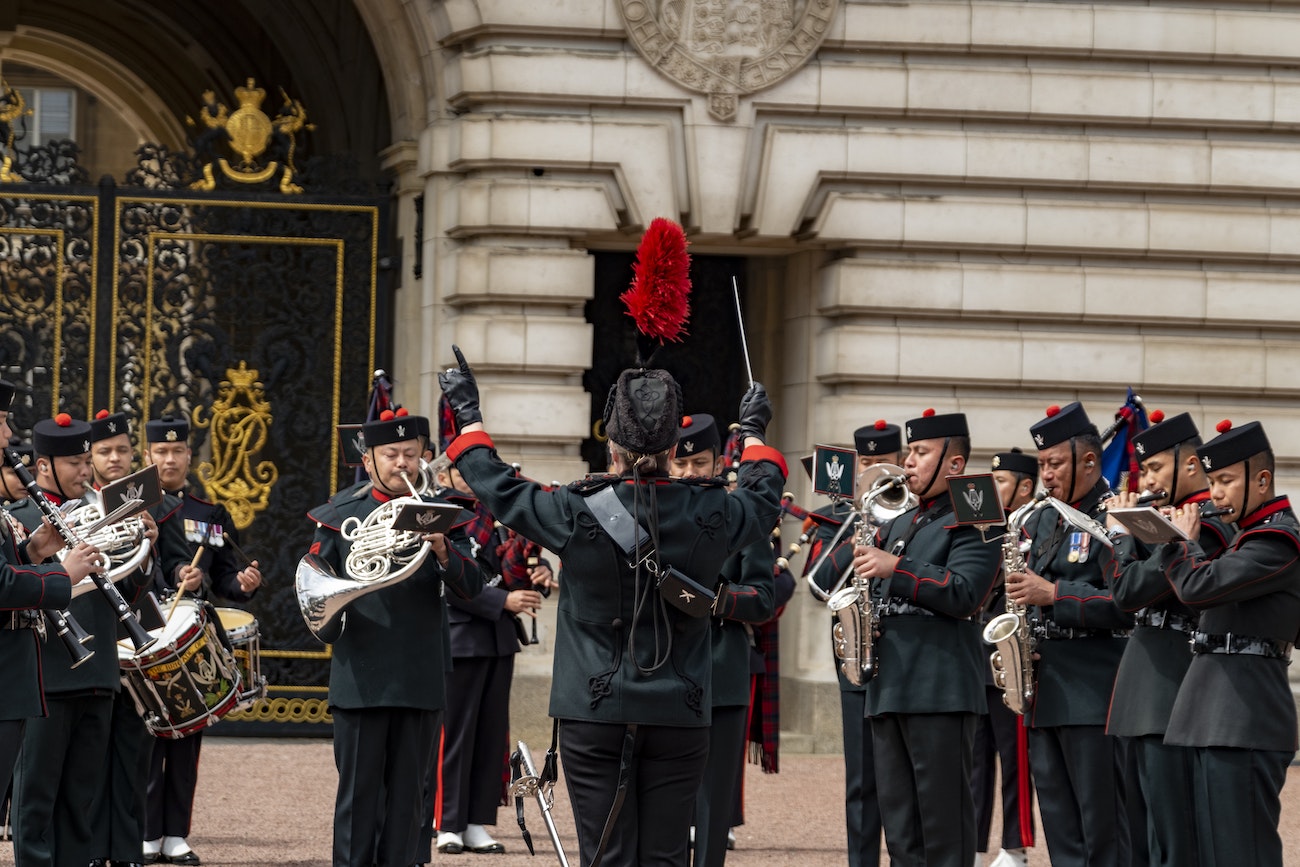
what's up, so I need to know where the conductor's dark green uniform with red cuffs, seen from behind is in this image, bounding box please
[443,428,785,867]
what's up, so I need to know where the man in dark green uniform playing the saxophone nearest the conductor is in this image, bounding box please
[853,409,1000,867]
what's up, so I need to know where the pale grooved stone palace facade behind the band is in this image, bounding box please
[358,0,1300,749]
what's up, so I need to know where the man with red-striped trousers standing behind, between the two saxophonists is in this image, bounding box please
[971,448,1039,867]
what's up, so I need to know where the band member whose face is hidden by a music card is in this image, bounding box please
[805,419,902,867]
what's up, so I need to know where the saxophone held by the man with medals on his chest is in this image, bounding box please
[984,491,1048,716]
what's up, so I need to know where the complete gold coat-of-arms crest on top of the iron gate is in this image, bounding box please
[185,78,316,194]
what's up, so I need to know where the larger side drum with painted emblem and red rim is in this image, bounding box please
[118,599,242,738]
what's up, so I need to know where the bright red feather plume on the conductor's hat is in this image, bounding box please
[619,217,690,342]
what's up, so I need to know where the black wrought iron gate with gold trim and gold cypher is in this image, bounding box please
[0,167,390,734]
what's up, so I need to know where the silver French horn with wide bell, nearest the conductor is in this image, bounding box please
[294,459,433,642]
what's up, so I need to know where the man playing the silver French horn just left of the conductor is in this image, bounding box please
[308,409,482,867]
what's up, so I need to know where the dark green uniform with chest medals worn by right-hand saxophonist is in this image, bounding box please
[1024,481,1132,867]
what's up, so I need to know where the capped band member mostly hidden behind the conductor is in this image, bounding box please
[668,412,776,867]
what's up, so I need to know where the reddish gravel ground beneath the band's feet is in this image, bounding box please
[0,734,1300,867]
